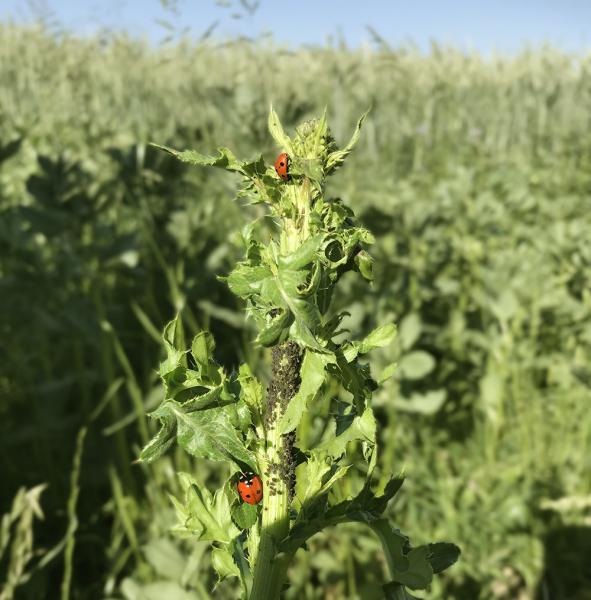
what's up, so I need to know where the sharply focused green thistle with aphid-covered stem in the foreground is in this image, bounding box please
[140,109,459,600]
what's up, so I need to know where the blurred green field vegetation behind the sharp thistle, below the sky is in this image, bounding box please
[0,25,591,600]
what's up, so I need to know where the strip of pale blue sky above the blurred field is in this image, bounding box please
[0,0,591,53]
